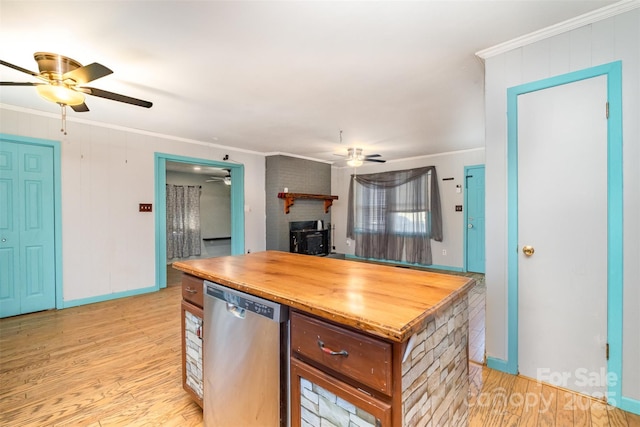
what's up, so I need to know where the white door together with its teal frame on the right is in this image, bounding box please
[504,62,623,397]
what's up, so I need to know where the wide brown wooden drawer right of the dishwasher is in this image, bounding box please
[291,312,391,396]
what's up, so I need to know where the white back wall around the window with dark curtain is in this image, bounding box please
[331,148,484,269]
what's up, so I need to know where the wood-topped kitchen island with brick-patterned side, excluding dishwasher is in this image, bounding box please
[173,251,475,426]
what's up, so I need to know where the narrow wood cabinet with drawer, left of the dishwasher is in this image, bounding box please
[180,274,204,407]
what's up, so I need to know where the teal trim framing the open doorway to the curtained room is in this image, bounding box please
[154,153,244,288]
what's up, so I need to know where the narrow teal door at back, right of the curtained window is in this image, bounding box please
[464,165,485,273]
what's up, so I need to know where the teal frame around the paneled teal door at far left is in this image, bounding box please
[0,133,64,310]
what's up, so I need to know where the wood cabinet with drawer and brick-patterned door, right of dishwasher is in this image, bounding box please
[291,312,392,427]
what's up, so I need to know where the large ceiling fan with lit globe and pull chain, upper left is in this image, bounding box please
[0,52,153,134]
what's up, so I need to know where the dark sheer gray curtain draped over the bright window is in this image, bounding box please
[347,166,442,265]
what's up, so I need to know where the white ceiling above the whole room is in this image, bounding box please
[0,0,614,161]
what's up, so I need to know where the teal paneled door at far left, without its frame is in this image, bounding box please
[0,140,56,317]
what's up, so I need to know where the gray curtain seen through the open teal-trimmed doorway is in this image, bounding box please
[167,184,201,259]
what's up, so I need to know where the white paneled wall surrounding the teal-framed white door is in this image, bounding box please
[485,9,640,400]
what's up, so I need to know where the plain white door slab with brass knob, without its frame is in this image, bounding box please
[518,76,607,396]
